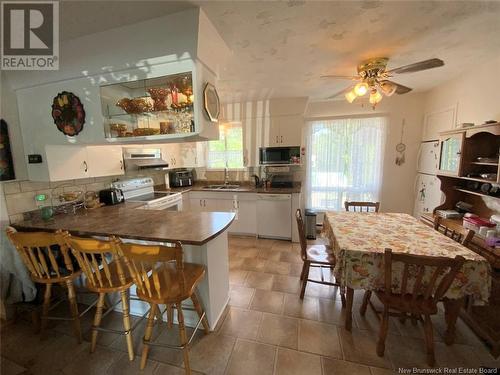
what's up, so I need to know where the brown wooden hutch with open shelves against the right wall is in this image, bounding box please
[421,122,500,357]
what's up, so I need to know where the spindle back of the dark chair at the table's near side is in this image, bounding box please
[384,249,465,303]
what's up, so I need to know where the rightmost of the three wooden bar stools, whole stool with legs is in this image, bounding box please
[115,242,210,374]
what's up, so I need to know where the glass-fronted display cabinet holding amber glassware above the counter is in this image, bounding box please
[100,72,196,141]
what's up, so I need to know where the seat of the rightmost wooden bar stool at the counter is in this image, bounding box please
[137,263,205,304]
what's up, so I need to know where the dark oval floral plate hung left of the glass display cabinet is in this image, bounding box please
[52,91,85,136]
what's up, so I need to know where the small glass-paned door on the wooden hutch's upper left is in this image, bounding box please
[438,132,465,176]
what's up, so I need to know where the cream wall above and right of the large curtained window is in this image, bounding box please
[305,93,424,214]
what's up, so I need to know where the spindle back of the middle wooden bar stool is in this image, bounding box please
[63,232,127,289]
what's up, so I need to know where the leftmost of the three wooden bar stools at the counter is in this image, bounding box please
[6,228,82,343]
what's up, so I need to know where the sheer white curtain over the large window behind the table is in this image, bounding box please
[306,117,387,211]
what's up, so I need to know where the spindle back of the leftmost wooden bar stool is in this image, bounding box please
[6,228,74,282]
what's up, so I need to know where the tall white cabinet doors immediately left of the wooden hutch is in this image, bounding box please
[413,141,444,218]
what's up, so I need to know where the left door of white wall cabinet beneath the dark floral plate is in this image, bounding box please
[45,145,90,181]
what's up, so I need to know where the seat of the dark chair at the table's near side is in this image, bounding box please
[375,291,437,315]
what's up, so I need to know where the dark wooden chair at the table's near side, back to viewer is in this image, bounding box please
[375,249,465,366]
